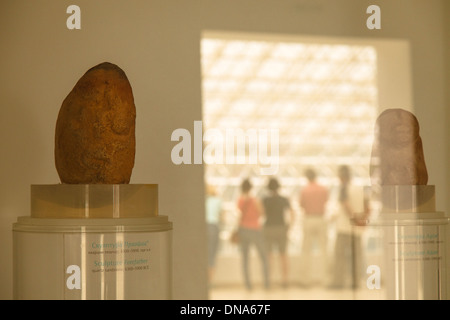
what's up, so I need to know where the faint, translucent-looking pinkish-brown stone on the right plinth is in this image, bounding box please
[371,109,428,185]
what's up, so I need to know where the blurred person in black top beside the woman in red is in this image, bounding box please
[263,178,294,287]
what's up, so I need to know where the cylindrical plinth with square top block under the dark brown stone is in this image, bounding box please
[13,185,172,300]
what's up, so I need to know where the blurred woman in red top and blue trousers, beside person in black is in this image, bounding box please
[237,179,270,290]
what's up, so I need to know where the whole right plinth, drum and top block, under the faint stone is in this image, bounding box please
[368,186,449,300]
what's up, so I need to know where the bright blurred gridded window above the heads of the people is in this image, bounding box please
[201,37,378,254]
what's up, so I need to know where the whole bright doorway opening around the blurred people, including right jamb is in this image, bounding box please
[201,32,411,298]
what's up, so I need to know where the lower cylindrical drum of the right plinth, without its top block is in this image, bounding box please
[377,212,448,300]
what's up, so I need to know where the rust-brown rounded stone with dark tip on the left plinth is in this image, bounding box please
[55,62,136,184]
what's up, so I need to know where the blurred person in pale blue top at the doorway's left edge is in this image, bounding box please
[205,185,222,283]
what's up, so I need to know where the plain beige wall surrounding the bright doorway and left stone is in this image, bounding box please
[0,0,450,299]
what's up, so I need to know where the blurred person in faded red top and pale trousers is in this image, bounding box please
[299,169,329,286]
